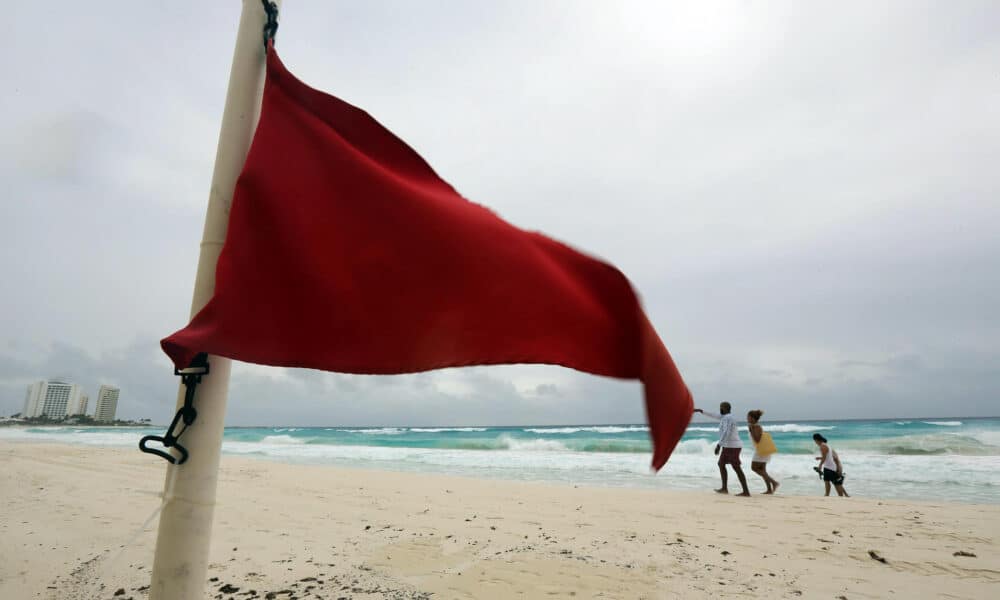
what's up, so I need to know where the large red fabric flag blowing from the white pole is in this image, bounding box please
[161,48,692,469]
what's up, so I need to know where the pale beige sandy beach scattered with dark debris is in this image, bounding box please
[0,442,1000,600]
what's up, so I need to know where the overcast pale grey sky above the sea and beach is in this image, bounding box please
[0,0,1000,425]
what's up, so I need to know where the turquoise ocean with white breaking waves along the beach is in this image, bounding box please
[0,417,1000,504]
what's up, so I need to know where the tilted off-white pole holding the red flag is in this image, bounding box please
[149,0,281,600]
